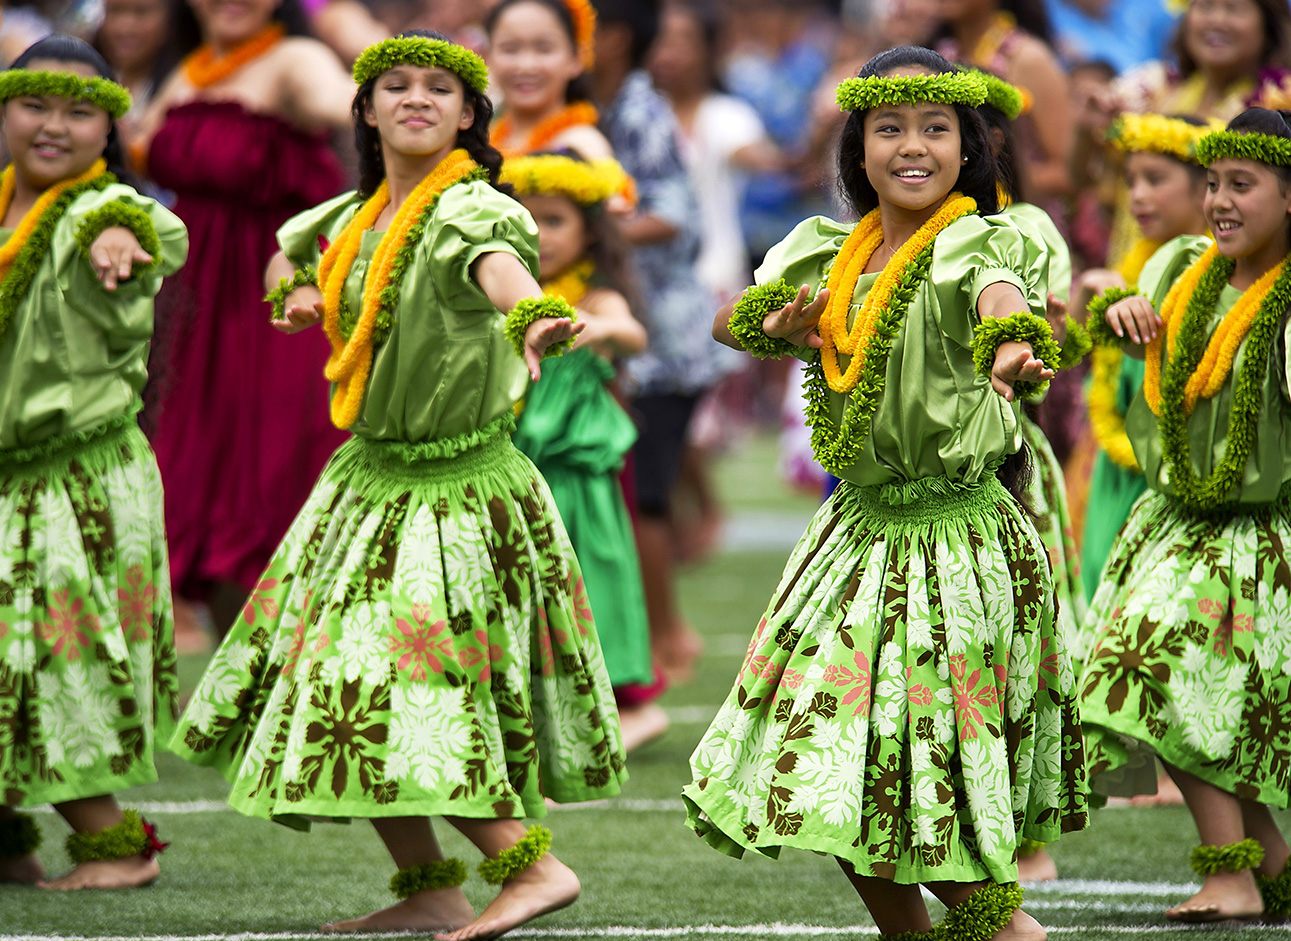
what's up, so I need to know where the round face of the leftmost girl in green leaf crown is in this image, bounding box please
[4,59,112,190]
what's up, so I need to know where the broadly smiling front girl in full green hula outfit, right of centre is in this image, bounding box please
[683,48,1086,938]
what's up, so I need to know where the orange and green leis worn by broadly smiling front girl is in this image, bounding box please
[806,192,977,470]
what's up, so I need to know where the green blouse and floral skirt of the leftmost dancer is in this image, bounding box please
[0,183,188,807]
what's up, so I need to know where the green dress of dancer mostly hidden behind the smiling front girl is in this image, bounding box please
[995,203,1087,637]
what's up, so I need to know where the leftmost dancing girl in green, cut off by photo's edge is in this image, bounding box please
[0,35,187,889]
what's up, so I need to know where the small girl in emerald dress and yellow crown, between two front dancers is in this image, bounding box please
[502,151,667,751]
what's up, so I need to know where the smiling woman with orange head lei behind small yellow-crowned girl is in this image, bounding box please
[484,0,613,160]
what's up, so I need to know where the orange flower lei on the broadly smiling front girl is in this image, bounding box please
[818,192,977,394]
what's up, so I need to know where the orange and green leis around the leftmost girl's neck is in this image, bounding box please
[0,160,116,339]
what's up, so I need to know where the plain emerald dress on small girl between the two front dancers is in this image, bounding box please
[515,347,655,689]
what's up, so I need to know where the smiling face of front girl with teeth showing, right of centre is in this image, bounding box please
[865,76,962,210]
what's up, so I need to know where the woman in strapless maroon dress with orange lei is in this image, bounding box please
[138,0,354,632]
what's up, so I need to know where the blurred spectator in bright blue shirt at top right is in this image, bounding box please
[1044,0,1175,74]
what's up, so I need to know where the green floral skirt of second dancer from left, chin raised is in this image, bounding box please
[173,421,626,826]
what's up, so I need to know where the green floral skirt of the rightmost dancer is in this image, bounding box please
[1081,491,1291,807]
